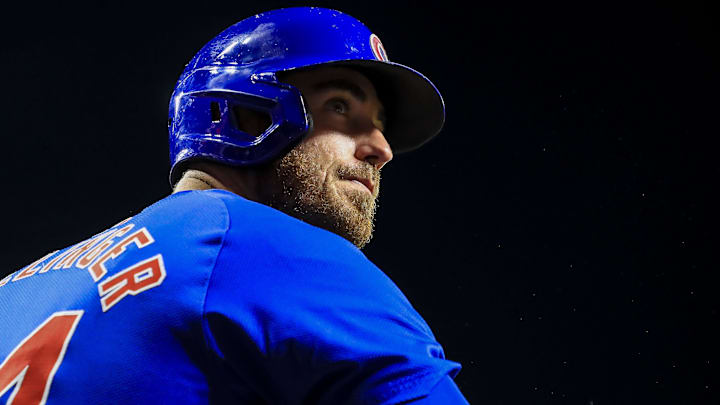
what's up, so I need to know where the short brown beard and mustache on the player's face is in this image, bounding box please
[269,144,380,249]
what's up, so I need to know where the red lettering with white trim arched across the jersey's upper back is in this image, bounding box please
[0,218,166,312]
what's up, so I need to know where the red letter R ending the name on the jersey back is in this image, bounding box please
[98,254,165,312]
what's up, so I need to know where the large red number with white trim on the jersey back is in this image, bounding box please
[0,311,83,405]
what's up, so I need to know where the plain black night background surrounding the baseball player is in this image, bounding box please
[0,1,720,404]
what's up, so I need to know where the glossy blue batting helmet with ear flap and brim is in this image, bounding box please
[168,7,445,184]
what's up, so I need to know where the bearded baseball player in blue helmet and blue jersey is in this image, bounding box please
[0,8,467,404]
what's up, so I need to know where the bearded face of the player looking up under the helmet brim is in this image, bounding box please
[270,67,392,248]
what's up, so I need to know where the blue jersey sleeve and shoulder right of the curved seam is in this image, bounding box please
[203,192,460,403]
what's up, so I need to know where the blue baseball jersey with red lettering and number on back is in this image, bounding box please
[0,190,465,404]
